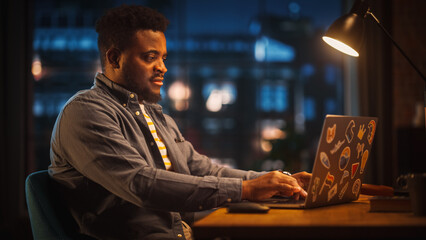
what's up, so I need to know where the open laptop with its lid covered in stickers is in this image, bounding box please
[261,115,378,208]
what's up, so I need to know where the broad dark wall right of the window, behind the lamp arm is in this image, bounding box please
[358,0,426,185]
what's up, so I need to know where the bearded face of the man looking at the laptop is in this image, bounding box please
[120,30,167,103]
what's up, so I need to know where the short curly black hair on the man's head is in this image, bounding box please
[96,4,169,69]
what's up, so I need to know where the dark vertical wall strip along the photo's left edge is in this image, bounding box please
[0,0,32,239]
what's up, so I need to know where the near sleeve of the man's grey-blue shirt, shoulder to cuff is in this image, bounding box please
[51,99,242,211]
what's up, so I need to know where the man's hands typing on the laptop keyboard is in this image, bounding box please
[242,171,311,201]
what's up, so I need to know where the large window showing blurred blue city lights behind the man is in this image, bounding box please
[33,0,343,170]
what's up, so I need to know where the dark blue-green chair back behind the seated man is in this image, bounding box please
[25,170,93,240]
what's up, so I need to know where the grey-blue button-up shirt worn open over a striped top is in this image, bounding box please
[49,73,262,239]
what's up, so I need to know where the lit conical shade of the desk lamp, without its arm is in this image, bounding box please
[322,12,365,57]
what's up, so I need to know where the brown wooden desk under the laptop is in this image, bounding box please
[193,196,426,240]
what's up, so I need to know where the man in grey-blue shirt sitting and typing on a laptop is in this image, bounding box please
[49,5,310,239]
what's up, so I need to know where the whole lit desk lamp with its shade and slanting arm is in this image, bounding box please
[322,0,426,125]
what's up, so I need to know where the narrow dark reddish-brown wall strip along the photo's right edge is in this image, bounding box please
[392,0,426,174]
